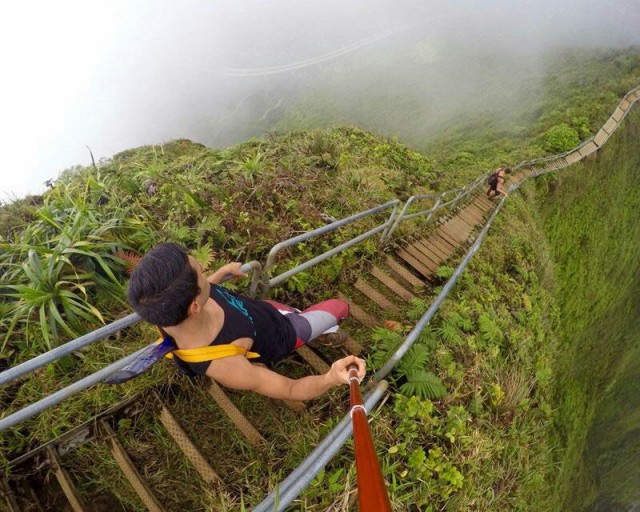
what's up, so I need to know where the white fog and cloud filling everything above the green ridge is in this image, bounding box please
[0,0,640,201]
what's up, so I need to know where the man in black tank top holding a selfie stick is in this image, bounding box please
[128,243,365,400]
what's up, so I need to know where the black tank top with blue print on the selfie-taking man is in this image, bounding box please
[173,284,296,375]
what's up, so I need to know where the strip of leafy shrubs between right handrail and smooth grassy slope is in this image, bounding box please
[376,197,557,511]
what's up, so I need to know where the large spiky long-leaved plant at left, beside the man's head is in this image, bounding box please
[0,173,149,352]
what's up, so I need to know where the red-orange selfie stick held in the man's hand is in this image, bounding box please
[348,364,391,512]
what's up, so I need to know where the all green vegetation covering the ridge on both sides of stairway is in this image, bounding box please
[0,49,640,512]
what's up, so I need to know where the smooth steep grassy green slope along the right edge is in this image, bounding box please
[540,109,640,511]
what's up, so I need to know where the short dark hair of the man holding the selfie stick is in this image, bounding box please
[127,243,200,327]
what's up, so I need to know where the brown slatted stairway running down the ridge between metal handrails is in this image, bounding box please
[3,86,640,510]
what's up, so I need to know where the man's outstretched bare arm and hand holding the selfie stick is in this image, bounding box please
[207,356,365,400]
